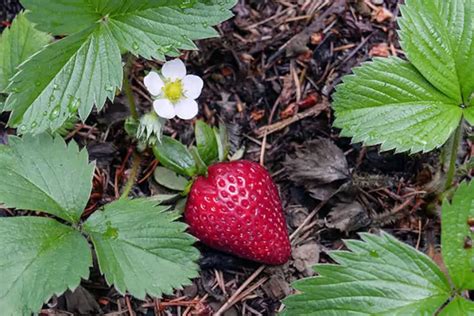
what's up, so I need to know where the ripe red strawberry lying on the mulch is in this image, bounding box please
[184,160,291,265]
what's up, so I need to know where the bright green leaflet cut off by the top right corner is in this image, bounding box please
[399,0,474,105]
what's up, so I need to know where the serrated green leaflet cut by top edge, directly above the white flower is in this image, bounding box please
[109,0,236,60]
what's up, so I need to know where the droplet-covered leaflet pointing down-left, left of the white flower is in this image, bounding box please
[5,26,123,134]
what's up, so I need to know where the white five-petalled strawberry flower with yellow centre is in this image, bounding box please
[144,59,204,120]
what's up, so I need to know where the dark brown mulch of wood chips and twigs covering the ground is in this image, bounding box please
[0,0,467,316]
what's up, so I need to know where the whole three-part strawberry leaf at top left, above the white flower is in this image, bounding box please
[3,0,236,134]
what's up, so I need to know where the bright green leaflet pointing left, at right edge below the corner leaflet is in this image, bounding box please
[333,57,462,153]
